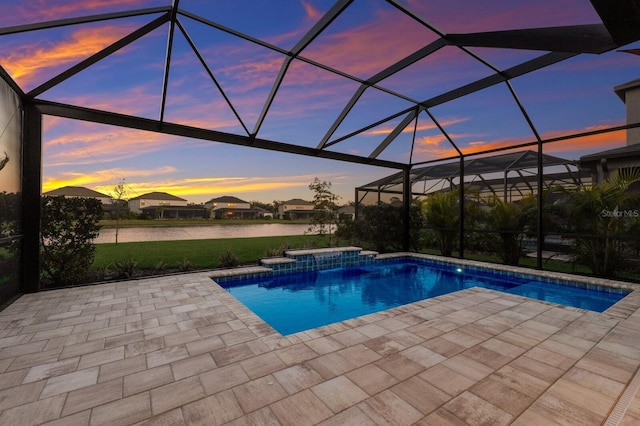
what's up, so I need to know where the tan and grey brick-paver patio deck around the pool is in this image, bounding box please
[0,256,640,426]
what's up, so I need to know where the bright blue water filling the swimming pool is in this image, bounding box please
[216,259,629,335]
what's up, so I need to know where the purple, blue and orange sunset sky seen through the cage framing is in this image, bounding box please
[0,0,640,202]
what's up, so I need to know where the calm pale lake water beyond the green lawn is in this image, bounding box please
[93,223,318,244]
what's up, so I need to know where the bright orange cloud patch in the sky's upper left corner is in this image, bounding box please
[0,26,134,87]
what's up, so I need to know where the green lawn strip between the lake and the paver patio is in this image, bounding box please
[92,235,328,269]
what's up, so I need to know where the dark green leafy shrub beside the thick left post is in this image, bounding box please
[40,197,102,287]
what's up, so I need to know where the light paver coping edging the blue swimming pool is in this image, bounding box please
[208,252,640,349]
